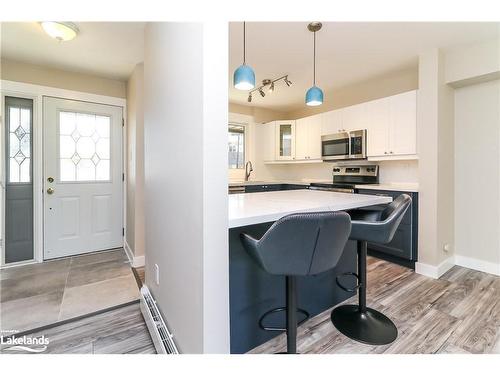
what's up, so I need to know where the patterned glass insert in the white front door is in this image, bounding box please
[59,111,111,182]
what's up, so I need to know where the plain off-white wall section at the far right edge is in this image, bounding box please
[455,80,500,272]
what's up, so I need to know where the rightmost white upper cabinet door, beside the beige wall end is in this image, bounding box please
[389,91,417,155]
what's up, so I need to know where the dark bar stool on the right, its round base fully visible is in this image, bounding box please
[331,194,411,345]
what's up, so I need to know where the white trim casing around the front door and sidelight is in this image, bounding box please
[0,80,127,268]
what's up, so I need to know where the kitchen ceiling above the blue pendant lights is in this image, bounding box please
[229,22,500,111]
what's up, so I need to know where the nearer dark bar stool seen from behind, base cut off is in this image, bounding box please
[241,212,351,354]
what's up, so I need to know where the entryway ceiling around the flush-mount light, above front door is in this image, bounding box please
[1,22,146,80]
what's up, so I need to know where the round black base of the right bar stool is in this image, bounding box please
[331,305,398,345]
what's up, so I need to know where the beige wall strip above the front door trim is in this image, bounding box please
[0,59,127,98]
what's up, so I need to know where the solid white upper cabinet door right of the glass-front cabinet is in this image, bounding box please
[295,114,323,160]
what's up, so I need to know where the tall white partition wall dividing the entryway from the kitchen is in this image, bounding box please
[144,23,229,353]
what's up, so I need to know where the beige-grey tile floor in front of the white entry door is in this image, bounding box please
[0,249,139,332]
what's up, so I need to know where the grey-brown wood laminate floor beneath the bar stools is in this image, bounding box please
[251,257,500,354]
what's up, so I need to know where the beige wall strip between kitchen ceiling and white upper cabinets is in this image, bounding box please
[287,66,418,119]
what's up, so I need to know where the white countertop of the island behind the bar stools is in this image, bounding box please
[228,190,392,228]
